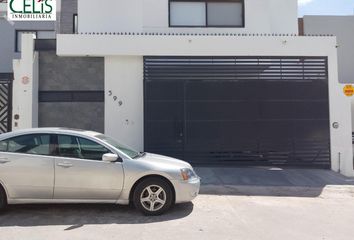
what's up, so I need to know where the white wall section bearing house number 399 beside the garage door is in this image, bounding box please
[105,56,144,151]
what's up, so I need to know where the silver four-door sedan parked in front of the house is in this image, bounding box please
[0,128,200,215]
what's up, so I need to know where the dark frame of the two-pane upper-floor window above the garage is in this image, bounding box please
[168,0,245,28]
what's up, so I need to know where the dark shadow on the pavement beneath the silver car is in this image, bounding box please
[0,203,193,229]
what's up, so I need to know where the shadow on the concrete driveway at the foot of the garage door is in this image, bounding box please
[195,167,354,197]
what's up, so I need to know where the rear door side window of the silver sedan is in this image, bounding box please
[0,134,50,155]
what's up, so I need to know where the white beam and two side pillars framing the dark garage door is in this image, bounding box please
[57,35,354,176]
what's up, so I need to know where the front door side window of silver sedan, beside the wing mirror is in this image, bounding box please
[58,135,110,160]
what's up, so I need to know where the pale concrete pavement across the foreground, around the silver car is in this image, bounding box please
[0,168,354,240]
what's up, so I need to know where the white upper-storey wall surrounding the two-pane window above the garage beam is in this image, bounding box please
[78,0,298,34]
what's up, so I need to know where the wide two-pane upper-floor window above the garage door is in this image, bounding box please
[169,0,244,27]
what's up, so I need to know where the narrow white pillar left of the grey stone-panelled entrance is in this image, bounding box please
[12,34,38,130]
